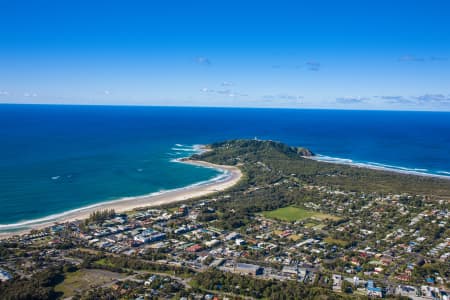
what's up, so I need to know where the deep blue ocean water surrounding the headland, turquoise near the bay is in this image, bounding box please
[0,105,450,229]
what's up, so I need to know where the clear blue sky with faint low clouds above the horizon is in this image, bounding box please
[0,0,450,111]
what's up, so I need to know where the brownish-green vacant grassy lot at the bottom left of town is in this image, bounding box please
[55,269,126,298]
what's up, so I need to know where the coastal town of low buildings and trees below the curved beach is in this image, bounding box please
[0,139,450,300]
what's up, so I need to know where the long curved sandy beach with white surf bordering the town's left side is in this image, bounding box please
[0,158,242,239]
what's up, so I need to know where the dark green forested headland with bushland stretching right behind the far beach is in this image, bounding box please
[194,140,450,199]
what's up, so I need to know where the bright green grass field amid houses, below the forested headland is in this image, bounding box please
[263,206,339,222]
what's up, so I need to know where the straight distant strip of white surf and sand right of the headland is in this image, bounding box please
[308,154,450,180]
